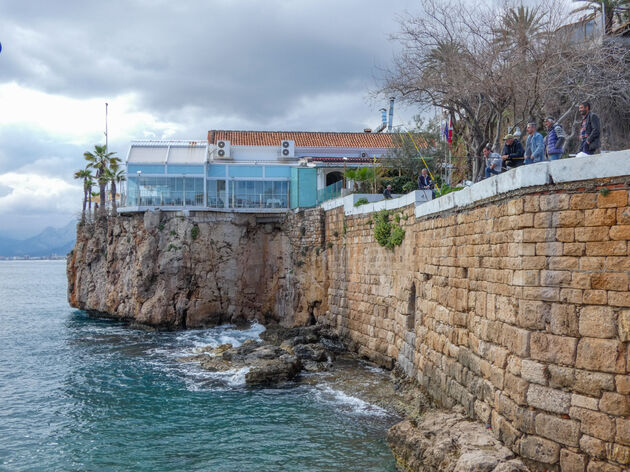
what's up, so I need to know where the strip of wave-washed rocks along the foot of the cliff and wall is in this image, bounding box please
[179,325,529,472]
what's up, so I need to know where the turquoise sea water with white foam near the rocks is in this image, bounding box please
[0,261,395,472]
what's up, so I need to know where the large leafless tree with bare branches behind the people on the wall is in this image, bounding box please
[381,0,630,180]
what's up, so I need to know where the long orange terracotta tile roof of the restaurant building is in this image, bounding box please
[208,130,397,148]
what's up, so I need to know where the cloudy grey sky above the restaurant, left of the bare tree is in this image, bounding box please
[0,0,428,237]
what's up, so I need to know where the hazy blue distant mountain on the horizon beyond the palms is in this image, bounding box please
[0,221,77,257]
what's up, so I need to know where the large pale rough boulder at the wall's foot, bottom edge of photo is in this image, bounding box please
[387,410,529,472]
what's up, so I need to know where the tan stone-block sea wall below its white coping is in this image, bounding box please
[321,179,630,472]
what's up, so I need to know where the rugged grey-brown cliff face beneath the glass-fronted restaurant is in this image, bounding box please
[67,210,325,328]
